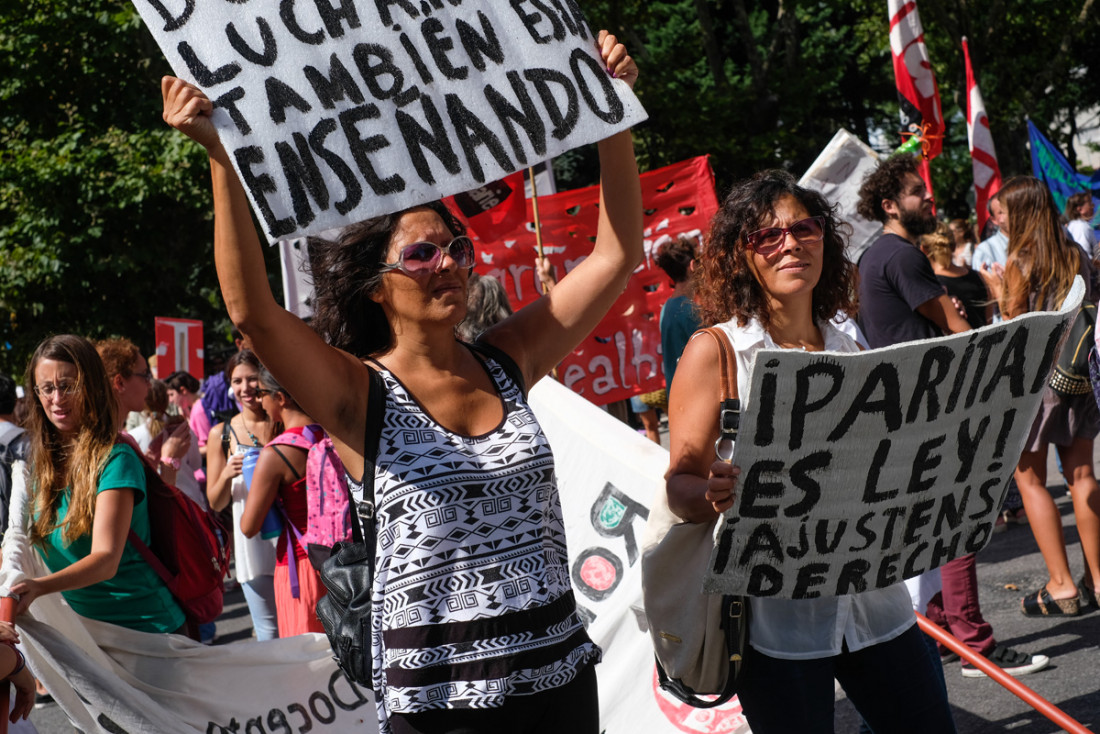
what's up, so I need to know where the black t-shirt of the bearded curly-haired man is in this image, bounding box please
[859,234,944,349]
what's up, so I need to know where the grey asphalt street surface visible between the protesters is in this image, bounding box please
[31,433,1100,734]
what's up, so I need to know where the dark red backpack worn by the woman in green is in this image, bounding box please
[119,441,230,624]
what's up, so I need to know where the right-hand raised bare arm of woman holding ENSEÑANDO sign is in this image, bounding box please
[483,31,642,385]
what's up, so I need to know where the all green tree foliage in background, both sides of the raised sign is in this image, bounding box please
[0,0,1100,373]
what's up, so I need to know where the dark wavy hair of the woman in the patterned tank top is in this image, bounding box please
[309,201,466,358]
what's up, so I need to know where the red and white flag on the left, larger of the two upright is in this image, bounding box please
[888,0,944,163]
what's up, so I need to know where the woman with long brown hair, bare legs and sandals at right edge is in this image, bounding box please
[983,176,1100,616]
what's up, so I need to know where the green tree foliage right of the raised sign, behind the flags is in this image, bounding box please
[572,0,1100,216]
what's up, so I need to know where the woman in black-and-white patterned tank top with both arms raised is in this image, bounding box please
[163,32,642,734]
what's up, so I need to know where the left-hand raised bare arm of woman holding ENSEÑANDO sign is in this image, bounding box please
[161,77,369,459]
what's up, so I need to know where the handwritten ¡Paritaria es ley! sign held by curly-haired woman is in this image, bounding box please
[704,277,1085,599]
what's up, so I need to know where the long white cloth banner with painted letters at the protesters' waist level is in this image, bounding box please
[0,380,748,734]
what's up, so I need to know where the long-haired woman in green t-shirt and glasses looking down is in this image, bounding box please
[12,335,185,633]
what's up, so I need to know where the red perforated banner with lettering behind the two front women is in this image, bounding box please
[475,156,718,405]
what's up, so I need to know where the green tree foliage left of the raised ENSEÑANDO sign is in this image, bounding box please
[0,0,242,374]
